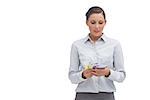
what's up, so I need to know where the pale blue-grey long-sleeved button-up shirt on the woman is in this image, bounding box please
[69,34,126,93]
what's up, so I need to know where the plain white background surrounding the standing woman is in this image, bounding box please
[0,0,150,100]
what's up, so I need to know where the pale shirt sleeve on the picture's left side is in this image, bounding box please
[68,44,86,84]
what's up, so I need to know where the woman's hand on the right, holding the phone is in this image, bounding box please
[92,67,110,76]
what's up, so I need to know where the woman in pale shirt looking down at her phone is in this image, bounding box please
[69,6,125,100]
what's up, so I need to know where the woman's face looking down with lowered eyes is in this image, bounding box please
[86,13,106,37]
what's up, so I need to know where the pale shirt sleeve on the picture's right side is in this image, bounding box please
[108,42,126,82]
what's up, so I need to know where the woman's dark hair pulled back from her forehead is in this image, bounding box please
[85,6,106,21]
